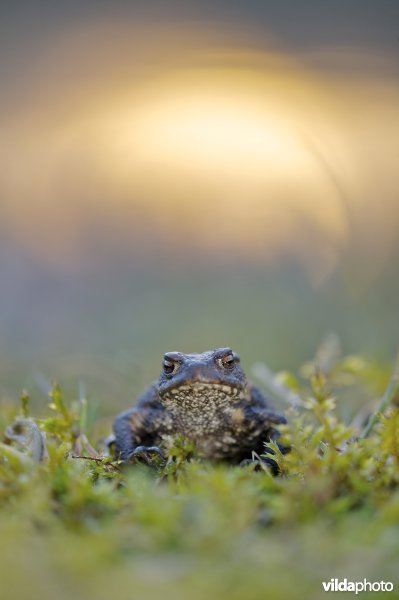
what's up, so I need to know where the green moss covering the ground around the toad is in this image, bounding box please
[0,347,399,600]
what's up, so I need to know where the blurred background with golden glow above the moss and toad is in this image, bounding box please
[0,0,399,413]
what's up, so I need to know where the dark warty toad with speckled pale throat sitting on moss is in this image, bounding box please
[114,348,285,462]
